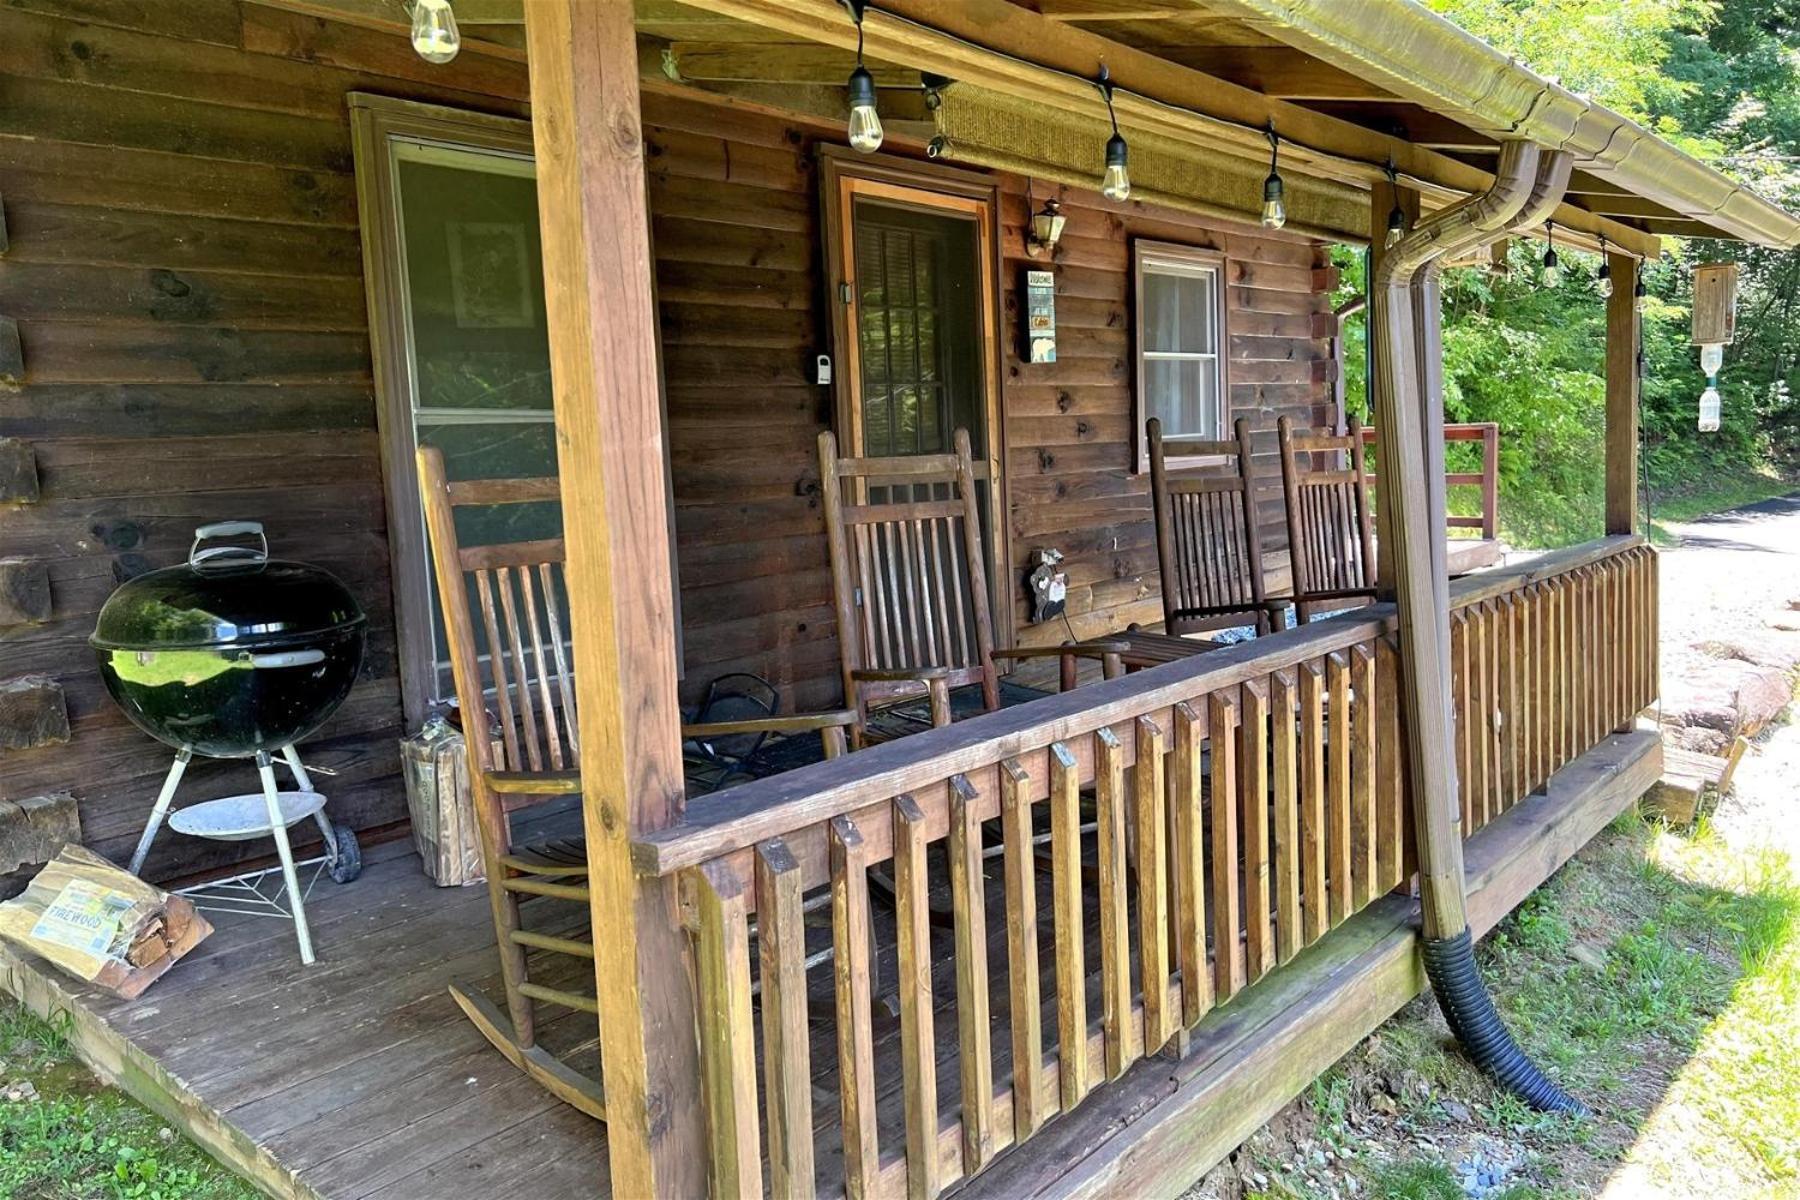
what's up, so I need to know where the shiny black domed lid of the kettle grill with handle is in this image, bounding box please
[88,522,364,649]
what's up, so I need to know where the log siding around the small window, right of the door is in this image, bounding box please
[1001,192,1337,644]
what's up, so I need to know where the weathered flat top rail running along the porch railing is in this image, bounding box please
[632,534,1643,874]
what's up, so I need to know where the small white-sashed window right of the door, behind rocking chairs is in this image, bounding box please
[1132,241,1229,471]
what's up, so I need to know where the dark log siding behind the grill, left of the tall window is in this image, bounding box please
[0,0,527,878]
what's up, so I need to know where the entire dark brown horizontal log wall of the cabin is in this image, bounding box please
[0,0,1330,878]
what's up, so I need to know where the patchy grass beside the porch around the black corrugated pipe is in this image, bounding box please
[1274,815,1800,1200]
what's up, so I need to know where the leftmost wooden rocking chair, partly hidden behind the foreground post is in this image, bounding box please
[418,448,855,1121]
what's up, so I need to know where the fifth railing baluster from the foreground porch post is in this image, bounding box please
[950,775,994,1175]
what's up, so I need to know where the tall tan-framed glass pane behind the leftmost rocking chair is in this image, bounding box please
[353,97,562,721]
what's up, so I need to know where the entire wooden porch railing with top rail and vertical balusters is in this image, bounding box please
[635,538,1656,1196]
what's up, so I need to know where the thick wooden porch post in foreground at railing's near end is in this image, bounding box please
[526,0,707,1196]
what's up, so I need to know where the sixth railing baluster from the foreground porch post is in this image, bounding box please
[1001,759,1055,1142]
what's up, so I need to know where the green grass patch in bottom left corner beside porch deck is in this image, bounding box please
[0,1000,257,1200]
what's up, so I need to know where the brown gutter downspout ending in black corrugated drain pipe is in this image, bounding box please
[1370,140,1586,1115]
